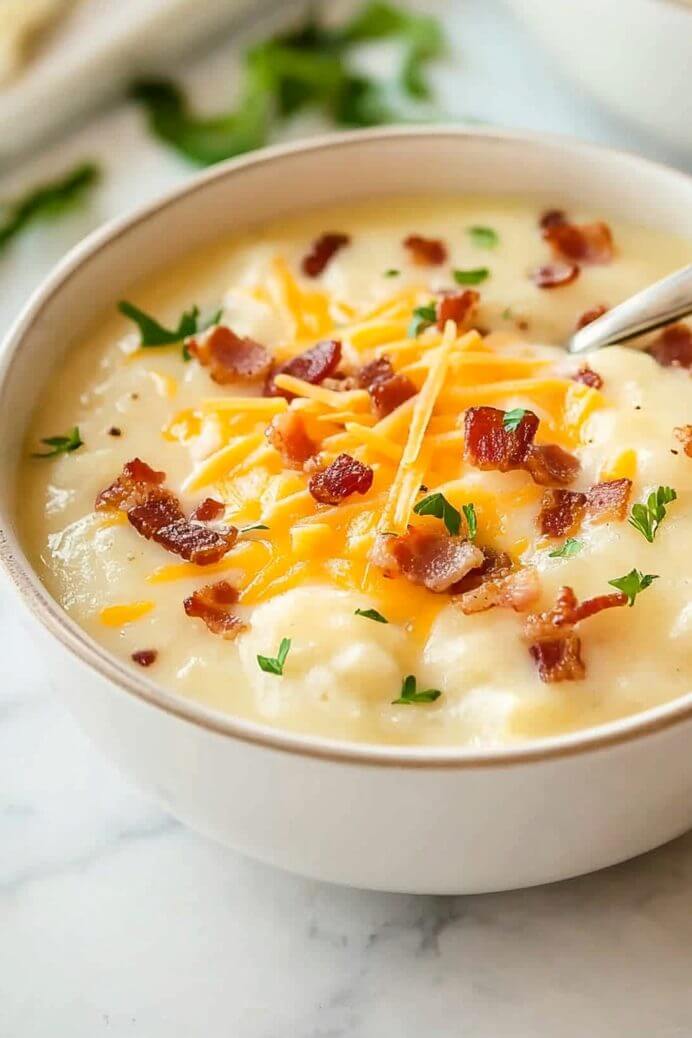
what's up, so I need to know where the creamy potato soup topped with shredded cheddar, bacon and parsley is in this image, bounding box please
[20,198,692,745]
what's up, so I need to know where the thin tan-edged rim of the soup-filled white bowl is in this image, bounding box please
[0,124,692,770]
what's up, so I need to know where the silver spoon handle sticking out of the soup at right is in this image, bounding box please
[566,264,692,353]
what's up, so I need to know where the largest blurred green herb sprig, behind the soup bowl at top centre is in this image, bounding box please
[131,0,444,165]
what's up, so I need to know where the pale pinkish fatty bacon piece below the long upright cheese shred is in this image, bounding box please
[371,526,483,592]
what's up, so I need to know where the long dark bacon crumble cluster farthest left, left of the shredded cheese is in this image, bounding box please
[95,458,238,566]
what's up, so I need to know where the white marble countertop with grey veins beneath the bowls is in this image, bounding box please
[0,0,692,1038]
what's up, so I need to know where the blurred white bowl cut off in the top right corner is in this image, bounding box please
[509,0,692,153]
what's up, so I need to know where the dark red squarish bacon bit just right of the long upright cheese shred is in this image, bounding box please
[464,407,538,472]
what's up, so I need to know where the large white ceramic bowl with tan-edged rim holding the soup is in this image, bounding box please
[0,128,692,894]
